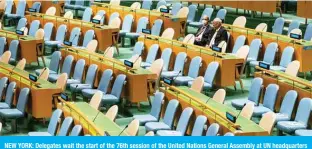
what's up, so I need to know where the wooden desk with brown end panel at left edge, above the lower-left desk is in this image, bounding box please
[0,30,42,64]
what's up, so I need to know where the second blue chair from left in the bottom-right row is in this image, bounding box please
[253,84,279,117]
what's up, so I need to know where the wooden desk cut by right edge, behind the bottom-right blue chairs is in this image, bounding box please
[254,66,312,124]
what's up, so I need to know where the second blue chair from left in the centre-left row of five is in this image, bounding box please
[49,55,74,82]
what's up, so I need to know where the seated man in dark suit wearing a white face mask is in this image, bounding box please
[194,16,212,46]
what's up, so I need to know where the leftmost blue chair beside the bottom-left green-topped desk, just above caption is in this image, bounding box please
[28,109,63,136]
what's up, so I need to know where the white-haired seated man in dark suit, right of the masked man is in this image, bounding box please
[206,18,228,48]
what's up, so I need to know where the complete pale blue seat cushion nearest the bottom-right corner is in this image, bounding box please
[276,121,307,134]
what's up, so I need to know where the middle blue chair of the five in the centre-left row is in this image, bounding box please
[66,59,86,86]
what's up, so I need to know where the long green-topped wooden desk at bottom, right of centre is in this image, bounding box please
[160,86,268,136]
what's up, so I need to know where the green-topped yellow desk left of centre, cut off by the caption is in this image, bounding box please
[57,99,128,136]
